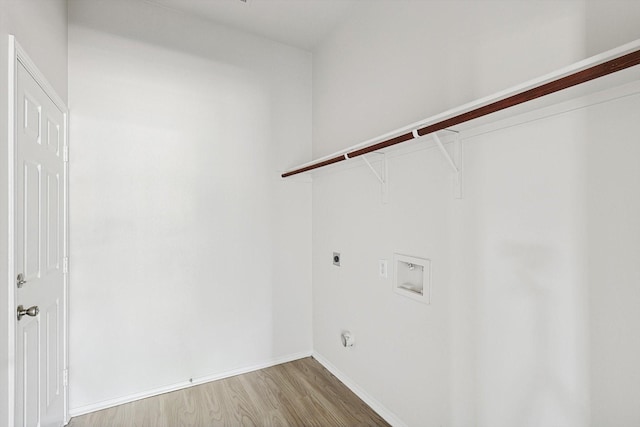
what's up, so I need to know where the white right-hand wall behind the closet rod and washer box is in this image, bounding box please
[313,2,640,427]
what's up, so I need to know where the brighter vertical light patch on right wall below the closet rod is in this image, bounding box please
[454,113,589,427]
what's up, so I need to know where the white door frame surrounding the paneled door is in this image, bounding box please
[7,34,69,425]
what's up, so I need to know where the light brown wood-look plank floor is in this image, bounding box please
[69,357,389,427]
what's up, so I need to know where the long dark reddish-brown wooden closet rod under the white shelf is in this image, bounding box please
[281,50,640,178]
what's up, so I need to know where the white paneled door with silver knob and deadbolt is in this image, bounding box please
[15,62,66,427]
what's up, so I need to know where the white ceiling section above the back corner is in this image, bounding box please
[147,0,358,50]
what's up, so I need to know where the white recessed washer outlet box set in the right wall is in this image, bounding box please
[393,254,431,304]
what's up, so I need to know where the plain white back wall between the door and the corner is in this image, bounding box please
[69,1,312,413]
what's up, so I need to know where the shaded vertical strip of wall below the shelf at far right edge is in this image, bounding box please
[584,92,640,426]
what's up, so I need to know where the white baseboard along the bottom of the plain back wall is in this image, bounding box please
[69,351,312,417]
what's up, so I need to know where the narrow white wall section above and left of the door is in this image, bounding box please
[0,0,67,425]
